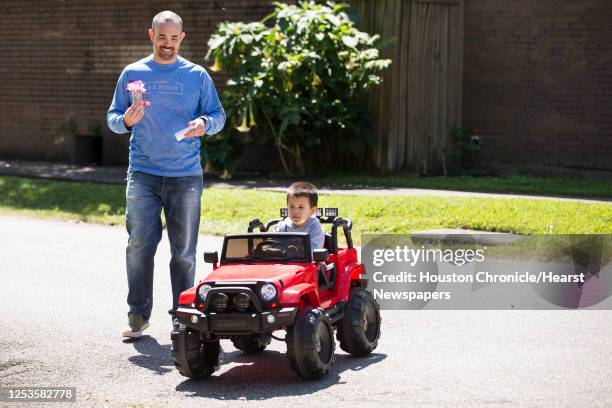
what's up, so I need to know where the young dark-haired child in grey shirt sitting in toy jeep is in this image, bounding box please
[274,181,325,249]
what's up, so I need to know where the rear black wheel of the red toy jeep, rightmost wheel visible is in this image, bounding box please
[337,288,380,356]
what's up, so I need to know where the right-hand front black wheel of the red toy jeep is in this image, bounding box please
[286,307,336,379]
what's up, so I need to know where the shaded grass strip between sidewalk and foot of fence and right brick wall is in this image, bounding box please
[320,174,612,198]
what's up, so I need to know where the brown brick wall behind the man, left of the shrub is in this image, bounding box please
[0,0,280,164]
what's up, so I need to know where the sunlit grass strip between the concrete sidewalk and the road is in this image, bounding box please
[0,177,612,240]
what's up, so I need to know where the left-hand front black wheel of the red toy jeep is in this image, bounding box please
[171,324,220,379]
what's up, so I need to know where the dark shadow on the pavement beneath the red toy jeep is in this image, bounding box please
[176,350,387,400]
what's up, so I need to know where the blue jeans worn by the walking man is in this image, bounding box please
[125,171,203,320]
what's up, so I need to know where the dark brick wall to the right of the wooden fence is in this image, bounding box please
[464,0,612,170]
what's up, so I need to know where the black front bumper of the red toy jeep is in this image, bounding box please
[176,307,297,336]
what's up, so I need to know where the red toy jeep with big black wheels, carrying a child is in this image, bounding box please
[172,208,380,379]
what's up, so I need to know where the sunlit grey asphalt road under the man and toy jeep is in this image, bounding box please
[0,217,612,407]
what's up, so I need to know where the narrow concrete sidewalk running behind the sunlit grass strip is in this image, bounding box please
[0,160,612,204]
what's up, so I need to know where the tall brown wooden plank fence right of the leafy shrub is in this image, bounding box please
[349,0,464,173]
